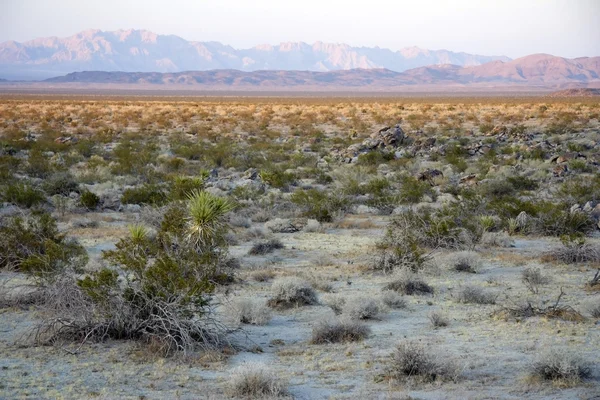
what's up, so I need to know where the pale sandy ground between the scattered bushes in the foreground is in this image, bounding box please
[0,214,600,399]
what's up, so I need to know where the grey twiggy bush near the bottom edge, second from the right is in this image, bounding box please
[389,341,458,382]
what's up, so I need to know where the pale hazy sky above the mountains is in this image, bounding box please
[0,0,600,58]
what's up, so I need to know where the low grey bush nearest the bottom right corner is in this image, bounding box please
[530,349,591,386]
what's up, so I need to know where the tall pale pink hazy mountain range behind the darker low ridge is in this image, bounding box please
[0,29,510,80]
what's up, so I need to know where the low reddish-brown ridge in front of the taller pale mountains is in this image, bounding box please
[38,54,600,89]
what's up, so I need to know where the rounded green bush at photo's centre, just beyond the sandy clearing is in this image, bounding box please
[291,189,348,222]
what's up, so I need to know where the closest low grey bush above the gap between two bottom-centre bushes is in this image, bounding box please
[310,318,371,344]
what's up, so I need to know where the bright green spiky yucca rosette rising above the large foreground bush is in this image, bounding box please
[187,191,234,247]
